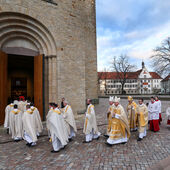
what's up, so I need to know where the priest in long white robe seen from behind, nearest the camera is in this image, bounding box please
[47,104,69,153]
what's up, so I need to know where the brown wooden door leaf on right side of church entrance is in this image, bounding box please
[34,55,43,119]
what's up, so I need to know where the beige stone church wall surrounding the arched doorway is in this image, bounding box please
[0,0,97,114]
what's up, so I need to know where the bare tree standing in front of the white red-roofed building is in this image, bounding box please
[111,55,136,94]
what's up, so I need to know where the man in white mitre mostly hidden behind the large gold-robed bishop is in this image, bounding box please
[104,96,114,138]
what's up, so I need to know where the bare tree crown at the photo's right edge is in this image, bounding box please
[151,37,170,75]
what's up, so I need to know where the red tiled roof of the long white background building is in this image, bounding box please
[98,69,162,80]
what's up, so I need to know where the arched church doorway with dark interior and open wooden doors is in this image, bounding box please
[0,12,56,124]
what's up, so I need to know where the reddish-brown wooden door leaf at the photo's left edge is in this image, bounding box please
[0,51,8,125]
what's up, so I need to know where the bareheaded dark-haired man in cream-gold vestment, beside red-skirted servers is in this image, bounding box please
[136,98,148,141]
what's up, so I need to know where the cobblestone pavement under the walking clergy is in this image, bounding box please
[0,99,170,170]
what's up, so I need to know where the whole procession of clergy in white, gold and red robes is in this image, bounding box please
[4,96,170,153]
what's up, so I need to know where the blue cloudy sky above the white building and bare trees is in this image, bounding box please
[96,0,170,71]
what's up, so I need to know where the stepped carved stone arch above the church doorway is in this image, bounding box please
[0,12,56,56]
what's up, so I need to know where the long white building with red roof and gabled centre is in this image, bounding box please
[98,62,162,95]
